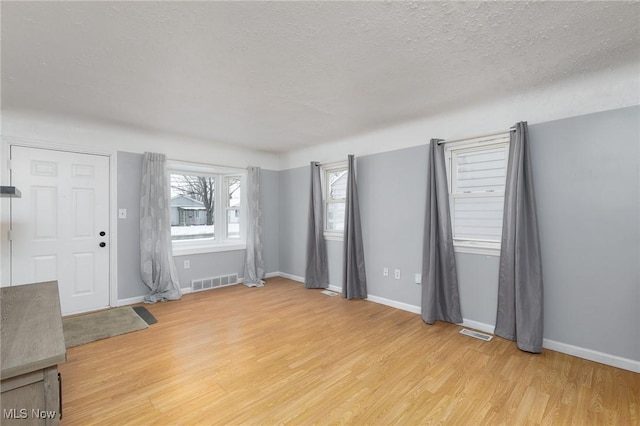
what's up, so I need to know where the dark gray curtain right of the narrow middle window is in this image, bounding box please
[342,155,367,299]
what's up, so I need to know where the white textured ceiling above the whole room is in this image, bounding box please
[0,1,640,152]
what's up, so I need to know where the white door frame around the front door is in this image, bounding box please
[0,136,118,307]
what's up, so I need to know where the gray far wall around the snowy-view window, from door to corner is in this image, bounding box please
[117,151,280,299]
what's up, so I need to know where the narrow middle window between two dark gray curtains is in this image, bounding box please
[322,162,348,240]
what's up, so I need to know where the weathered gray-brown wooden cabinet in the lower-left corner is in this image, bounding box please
[0,281,67,426]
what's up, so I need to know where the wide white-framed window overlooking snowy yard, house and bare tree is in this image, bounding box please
[168,162,246,255]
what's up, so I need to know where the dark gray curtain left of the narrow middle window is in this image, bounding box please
[304,161,329,288]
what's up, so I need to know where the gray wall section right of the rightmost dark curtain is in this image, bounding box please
[530,107,640,360]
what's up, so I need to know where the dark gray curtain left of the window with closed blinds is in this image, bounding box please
[421,139,462,324]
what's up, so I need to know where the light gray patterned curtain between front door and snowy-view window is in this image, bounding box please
[140,152,182,303]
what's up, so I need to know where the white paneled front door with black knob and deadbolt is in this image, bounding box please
[11,146,110,315]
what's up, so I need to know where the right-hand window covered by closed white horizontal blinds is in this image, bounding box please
[445,133,509,255]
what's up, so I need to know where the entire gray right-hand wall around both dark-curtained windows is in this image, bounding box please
[280,107,640,360]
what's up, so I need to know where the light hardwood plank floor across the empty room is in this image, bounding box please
[60,278,640,426]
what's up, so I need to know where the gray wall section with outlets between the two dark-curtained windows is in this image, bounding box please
[356,146,427,306]
